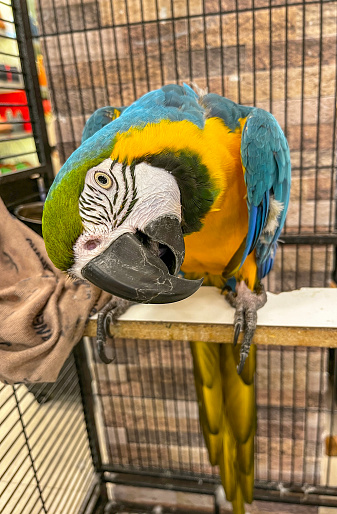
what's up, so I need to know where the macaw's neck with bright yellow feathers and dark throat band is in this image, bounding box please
[111,118,241,233]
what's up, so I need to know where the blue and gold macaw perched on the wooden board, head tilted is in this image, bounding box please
[43,85,290,514]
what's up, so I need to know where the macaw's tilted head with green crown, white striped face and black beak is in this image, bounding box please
[43,115,213,303]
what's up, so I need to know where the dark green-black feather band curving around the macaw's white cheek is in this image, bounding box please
[136,151,218,235]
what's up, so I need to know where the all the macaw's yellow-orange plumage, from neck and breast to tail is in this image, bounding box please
[111,110,257,514]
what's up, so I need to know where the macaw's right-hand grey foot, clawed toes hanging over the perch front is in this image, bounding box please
[226,280,267,375]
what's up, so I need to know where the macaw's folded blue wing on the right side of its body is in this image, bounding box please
[241,109,291,279]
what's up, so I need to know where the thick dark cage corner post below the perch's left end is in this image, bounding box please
[73,339,108,502]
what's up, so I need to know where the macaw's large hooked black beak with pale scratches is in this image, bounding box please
[82,216,202,303]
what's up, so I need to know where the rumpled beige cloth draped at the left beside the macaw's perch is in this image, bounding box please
[0,199,111,383]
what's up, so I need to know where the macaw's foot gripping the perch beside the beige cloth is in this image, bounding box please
[96,296,132,364]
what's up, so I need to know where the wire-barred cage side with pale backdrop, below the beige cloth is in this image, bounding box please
[0,357,95,514]
